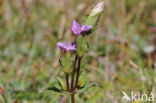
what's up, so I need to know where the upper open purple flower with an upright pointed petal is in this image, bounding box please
[71,20,92,35]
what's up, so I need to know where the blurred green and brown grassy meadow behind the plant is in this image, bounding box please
[0,0,156,103]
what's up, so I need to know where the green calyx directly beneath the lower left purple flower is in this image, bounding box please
[60,53,71,74]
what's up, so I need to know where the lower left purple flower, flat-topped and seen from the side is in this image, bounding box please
[57,42,76,52]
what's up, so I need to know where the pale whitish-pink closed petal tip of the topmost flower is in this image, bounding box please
[89,1,104,16]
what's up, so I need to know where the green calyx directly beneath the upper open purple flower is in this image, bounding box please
[77,36,88,58]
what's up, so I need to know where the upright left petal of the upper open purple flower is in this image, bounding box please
[71,20,81,35]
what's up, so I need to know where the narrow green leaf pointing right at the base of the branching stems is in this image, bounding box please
[77,82,99,93]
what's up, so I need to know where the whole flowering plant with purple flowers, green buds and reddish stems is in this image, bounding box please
[45,2,104,103]
